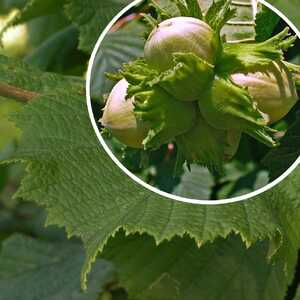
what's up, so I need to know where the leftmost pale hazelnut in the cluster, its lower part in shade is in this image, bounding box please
[100,79,149,148]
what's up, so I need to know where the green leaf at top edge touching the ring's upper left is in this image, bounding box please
[66,0,132,53]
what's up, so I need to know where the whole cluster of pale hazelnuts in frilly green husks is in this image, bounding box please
[101,0,298,171]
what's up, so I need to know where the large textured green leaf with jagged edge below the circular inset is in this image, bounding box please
[0,56,300,287]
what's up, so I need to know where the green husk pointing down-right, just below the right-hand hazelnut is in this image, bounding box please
[198,78,278,147]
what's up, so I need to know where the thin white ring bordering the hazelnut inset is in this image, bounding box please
[86,0,300,205]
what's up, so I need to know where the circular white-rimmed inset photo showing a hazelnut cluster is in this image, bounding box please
[87,0,300,204]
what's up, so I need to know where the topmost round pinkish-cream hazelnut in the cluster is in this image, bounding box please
[144,17,216,71]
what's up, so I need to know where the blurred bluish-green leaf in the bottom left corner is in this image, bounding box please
[0,235,115,300]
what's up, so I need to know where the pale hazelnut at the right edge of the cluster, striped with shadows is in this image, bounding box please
[232,62,298,124]
